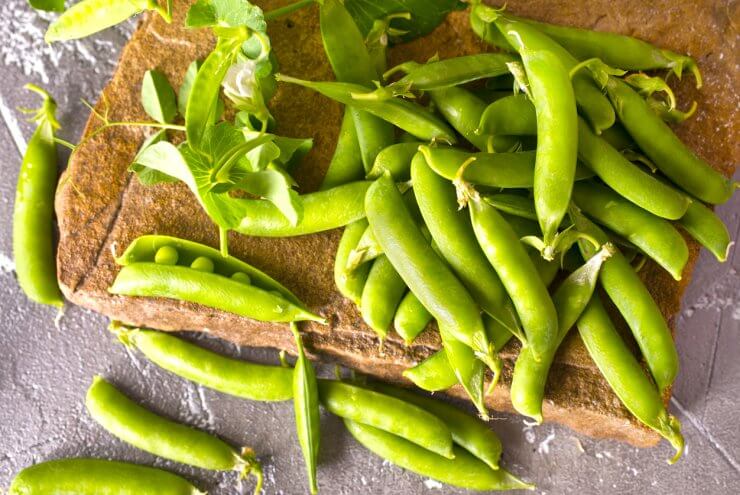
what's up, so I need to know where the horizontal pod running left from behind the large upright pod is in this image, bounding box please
[419,146,593,189]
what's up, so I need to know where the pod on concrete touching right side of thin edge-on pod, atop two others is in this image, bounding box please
[319,380,454,459]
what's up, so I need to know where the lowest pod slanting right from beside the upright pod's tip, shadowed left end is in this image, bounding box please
[573,182,689,280]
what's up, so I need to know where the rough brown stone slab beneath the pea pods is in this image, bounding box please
[56,0,740,446]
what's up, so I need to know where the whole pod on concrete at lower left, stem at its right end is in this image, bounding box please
[85,376,262,486]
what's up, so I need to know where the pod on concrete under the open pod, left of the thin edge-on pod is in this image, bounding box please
[110,324,293,401]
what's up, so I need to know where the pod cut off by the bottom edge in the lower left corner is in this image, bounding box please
[8,458,205,495]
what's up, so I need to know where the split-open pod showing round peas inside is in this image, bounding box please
[109,236,323,322]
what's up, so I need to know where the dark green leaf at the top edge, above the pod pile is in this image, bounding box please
[344,0,465,42]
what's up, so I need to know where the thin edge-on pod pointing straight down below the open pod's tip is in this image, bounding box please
[290,323,321,494]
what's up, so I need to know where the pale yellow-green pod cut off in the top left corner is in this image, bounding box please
[44,0,171,43]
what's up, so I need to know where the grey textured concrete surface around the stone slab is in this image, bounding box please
[0,0,740,494]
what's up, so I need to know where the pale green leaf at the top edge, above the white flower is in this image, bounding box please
[185,0,267,33]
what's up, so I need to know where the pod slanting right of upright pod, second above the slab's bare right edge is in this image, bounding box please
[578,119,690,220]
